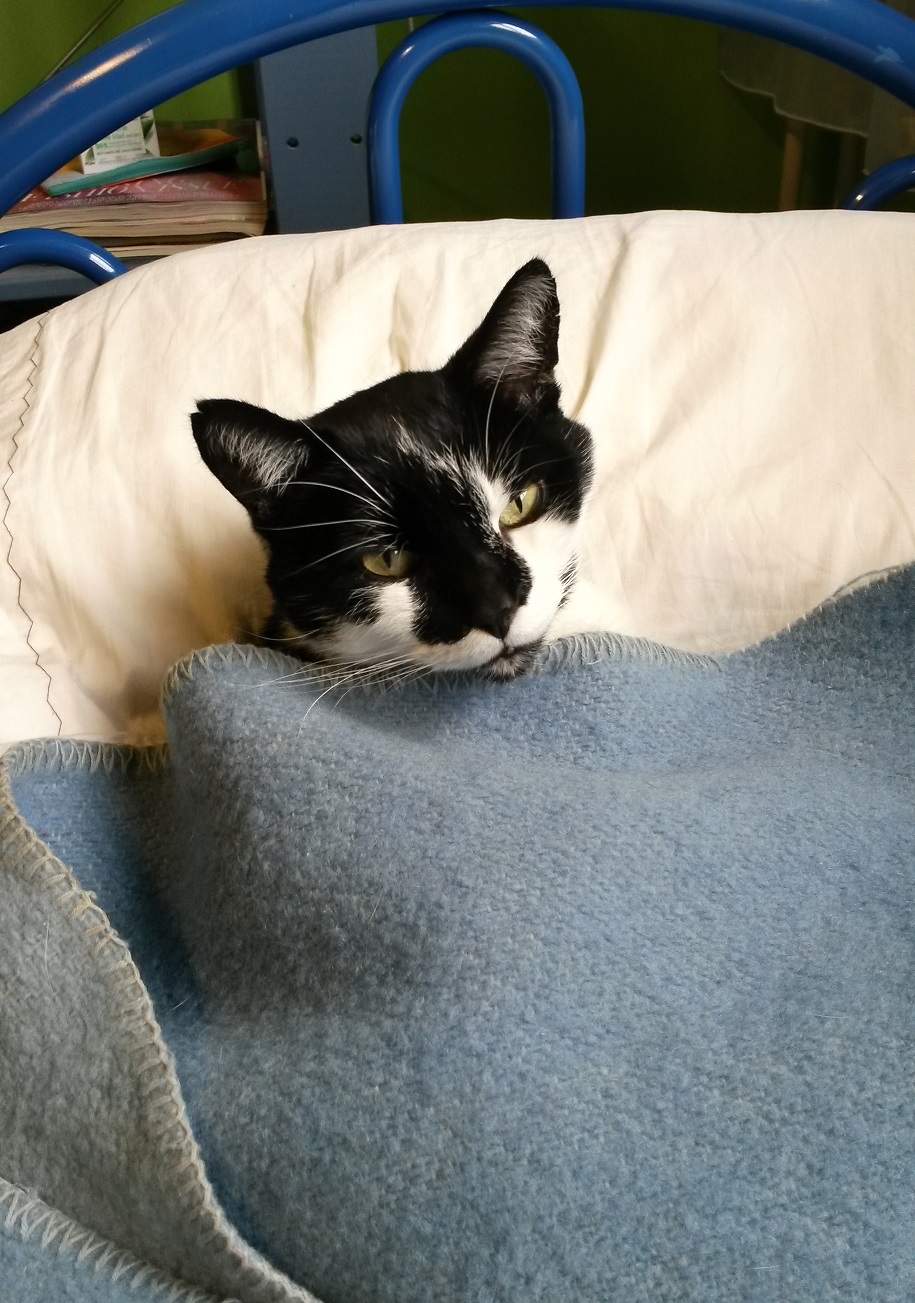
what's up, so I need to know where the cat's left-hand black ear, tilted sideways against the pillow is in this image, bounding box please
[190,399,308,524]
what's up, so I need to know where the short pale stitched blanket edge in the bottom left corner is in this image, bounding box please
[0,1177,223,1303]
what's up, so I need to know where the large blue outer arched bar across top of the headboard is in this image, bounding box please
[0,0,915,220]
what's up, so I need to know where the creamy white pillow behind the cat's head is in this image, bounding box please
[0,212,915,741]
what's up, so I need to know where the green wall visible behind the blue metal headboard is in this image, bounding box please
[0,0,808,213]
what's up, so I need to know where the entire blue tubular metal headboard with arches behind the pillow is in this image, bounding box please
[0,0,915,281]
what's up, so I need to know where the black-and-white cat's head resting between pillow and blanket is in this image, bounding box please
[192,261,592,678]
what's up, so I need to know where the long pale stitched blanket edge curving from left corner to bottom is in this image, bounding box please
[0,737,318,1303]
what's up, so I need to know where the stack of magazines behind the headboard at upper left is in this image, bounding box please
[0,121,267,258]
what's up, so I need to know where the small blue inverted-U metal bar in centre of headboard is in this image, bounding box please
[368,13,585,223]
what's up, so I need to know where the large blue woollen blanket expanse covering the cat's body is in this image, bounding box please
[5,571,915,1303]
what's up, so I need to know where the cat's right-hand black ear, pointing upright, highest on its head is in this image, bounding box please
[448,258,559,405]
